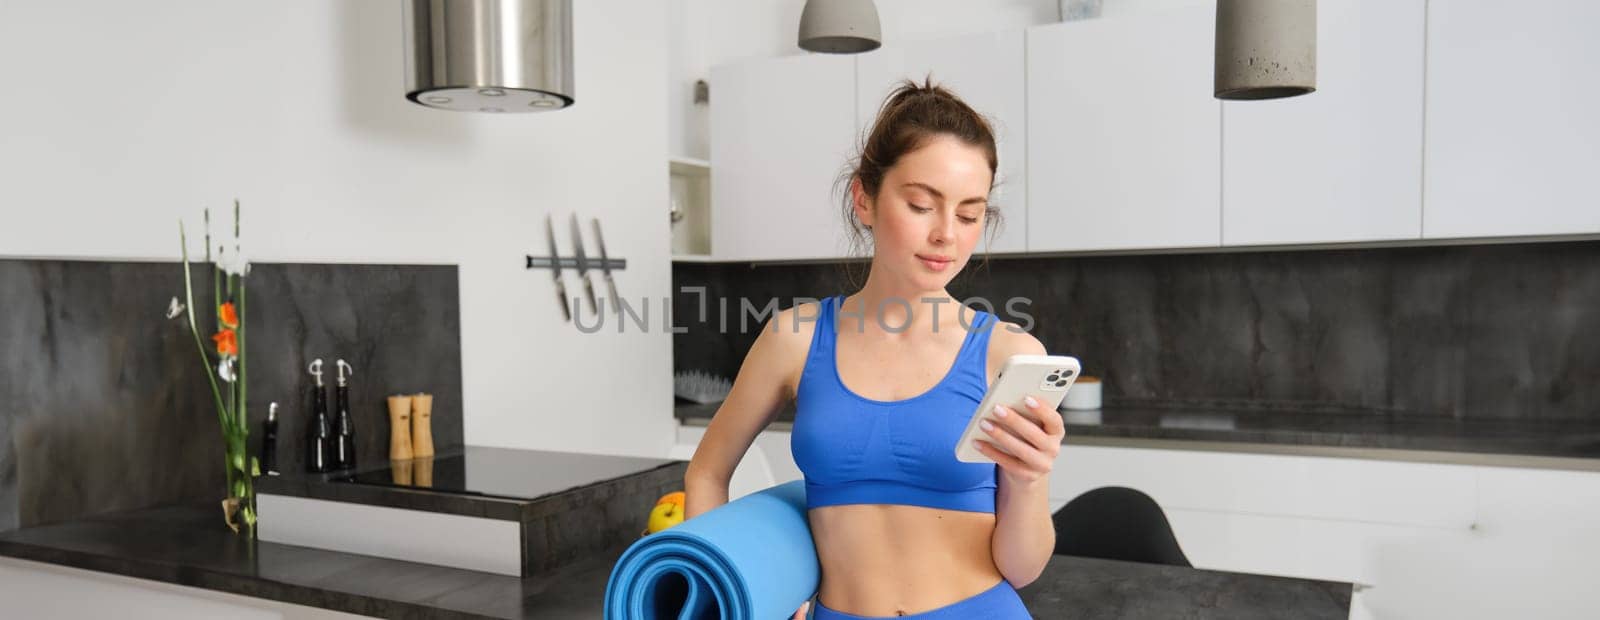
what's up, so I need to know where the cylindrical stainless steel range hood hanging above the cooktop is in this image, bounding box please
[405,0,574,112]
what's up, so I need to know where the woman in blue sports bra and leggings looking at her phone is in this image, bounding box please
[685,81,1064,618]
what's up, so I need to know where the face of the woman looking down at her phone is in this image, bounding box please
[853,136,992,291]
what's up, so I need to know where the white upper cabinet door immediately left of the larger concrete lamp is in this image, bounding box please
[1027,6,1222,252]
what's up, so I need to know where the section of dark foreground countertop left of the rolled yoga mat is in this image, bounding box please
[0,502,622,620]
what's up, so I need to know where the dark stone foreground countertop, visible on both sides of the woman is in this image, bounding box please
[0,503,1352,620]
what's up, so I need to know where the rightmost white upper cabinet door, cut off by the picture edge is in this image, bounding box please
[1422,0,1600,238]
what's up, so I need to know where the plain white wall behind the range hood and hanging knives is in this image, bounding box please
[0,0,674,454]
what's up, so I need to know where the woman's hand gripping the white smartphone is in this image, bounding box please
[978,396,1067,484]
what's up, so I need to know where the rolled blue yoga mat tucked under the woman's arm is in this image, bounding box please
[605,481,822,620]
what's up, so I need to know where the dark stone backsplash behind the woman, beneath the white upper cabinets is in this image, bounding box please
[672,241,1600,419]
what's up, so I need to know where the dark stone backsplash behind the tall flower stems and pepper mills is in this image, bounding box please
[0,260,462,531]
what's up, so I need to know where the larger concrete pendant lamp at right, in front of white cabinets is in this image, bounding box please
[1213,0,1317,99]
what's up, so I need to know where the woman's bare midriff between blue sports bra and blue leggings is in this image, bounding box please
[808,503,1002,615]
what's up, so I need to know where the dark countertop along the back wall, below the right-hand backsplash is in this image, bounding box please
[674,403,1600,459]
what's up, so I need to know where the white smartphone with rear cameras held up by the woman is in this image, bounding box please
[955,355,1082,463]
